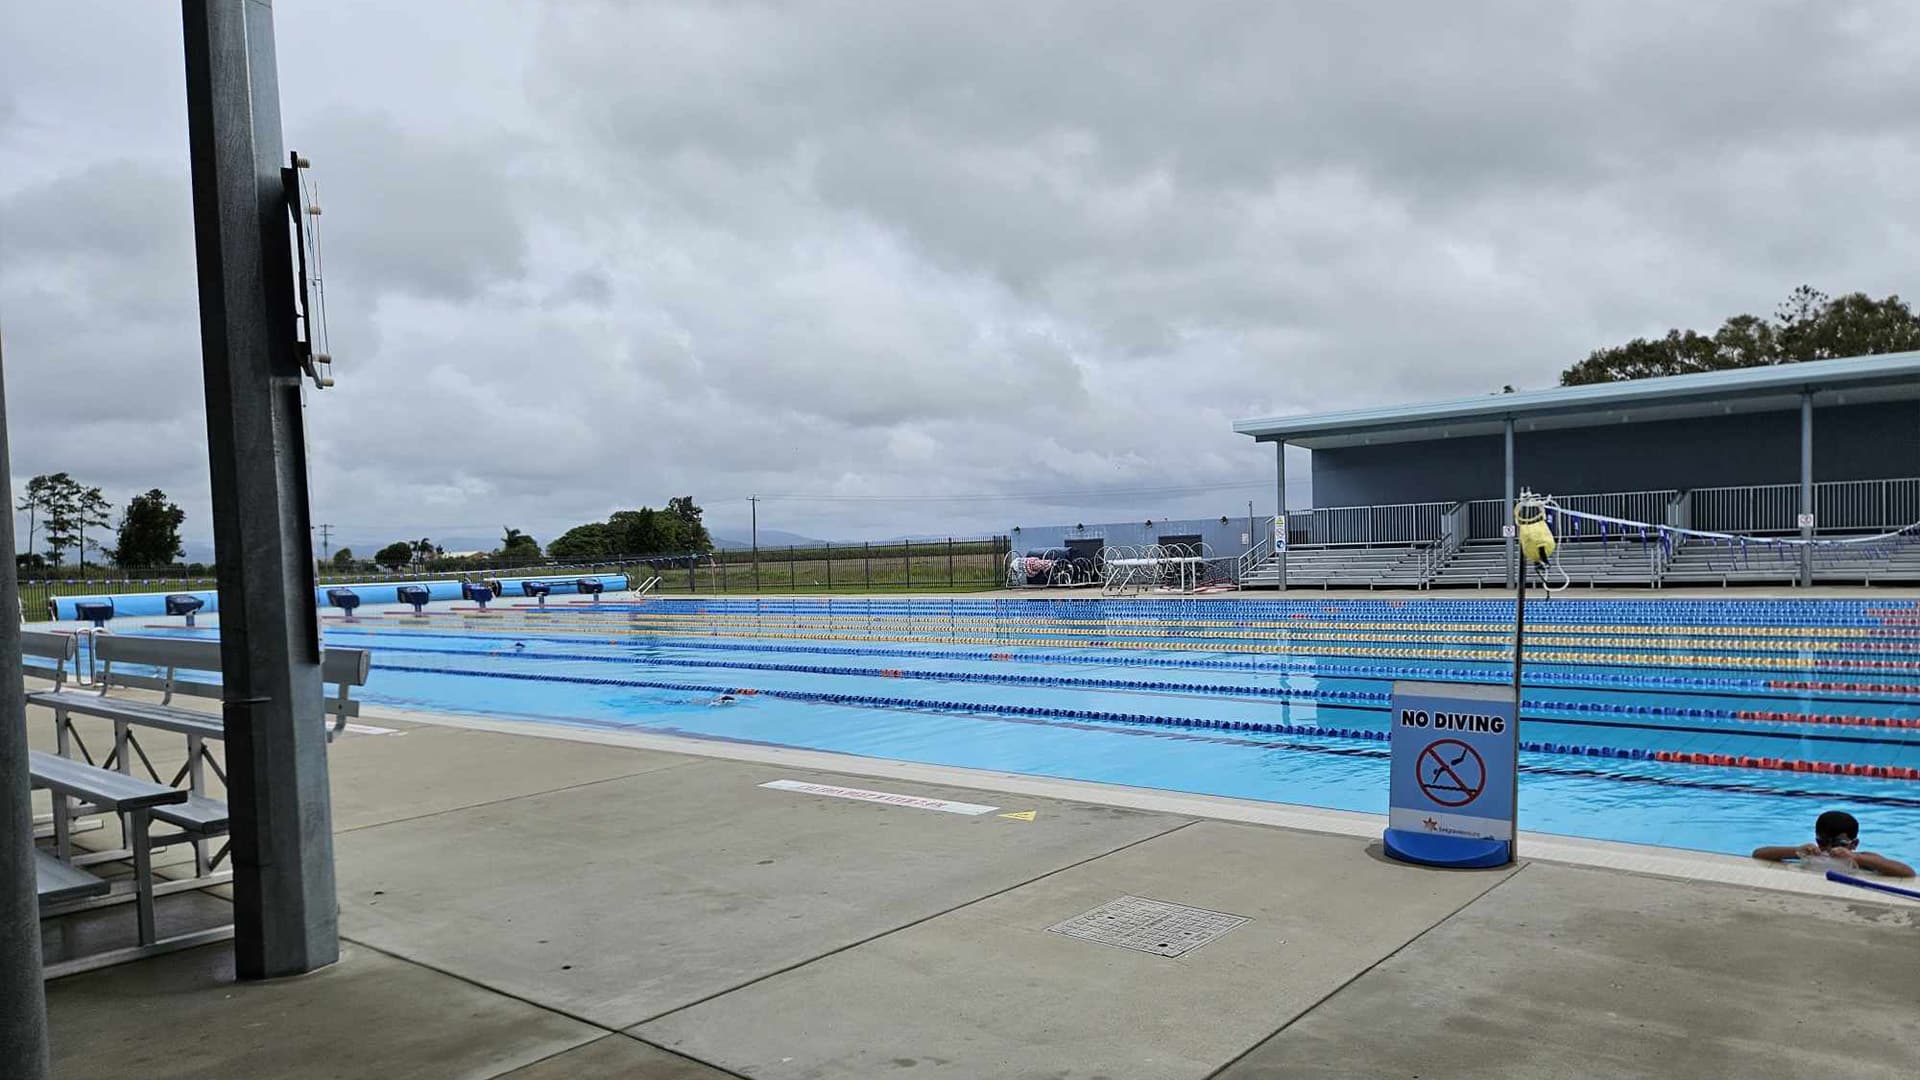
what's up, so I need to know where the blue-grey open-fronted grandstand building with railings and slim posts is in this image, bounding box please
[1235,352,1920,586]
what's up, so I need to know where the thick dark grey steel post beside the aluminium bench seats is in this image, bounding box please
[182,0,340,978]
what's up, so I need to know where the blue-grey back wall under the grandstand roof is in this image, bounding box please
[1313,402,1920,505]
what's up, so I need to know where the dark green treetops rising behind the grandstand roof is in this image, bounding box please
[1561,284,1920,386]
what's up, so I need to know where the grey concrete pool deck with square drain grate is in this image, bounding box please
[29,711,1920,1080]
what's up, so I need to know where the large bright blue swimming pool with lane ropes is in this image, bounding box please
[157,598,1920,857]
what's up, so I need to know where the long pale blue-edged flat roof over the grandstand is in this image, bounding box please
[1233,352,1920,450]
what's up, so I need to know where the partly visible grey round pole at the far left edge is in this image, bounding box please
[0,334,50,1080]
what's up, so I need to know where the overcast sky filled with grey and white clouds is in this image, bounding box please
[0,0,1920,548]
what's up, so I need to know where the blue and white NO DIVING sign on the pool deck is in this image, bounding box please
[1382,682,1521,867]
